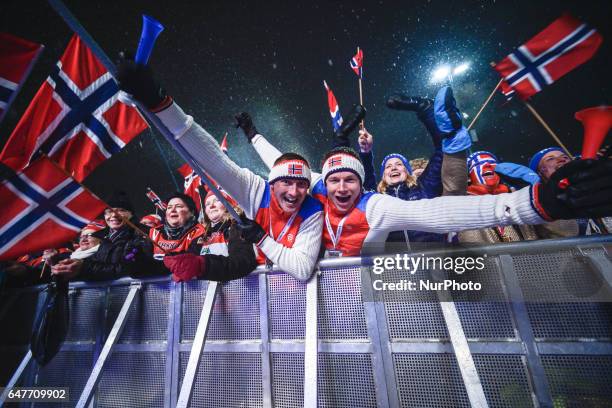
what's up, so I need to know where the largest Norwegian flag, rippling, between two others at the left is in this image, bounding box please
[0,35,147,181]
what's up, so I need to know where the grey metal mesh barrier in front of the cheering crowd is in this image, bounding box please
[0,236,612,407]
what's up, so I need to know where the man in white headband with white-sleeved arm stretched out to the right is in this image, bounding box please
[245,127,612,256]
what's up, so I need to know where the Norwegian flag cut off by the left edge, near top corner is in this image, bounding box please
[0,33,44,122]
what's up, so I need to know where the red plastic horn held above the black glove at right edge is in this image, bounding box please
[574,106,612,159]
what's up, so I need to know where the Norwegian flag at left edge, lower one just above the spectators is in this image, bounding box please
[0,156,106,260]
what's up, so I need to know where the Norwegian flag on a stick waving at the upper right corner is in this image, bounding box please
[494,14,603,99]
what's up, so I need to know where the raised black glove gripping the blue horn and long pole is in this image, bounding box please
[117,53,166,109]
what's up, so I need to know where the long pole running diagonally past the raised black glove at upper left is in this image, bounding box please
[48,0,241,223]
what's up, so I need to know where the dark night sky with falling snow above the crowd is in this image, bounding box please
[0,0,612,212]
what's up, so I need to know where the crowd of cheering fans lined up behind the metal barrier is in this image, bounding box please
[1,62,611,285]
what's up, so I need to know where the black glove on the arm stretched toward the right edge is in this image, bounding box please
[533,159,612,219]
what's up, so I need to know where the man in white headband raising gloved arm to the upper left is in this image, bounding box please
[118,60,323,281]
